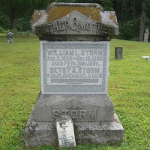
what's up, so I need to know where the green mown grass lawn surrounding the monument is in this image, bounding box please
[0,34,150,150]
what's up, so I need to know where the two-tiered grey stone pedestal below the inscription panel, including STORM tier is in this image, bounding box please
[24,93,124,146]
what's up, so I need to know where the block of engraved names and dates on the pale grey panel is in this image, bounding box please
[46,49,103,85]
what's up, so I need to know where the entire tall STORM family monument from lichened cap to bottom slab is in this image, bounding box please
[24,3,124,146]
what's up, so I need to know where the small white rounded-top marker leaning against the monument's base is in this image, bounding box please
[56,115,76,148]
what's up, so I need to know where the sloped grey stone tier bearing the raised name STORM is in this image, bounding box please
[33,93,114,122]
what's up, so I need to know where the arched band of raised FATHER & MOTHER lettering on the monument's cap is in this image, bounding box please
[36,18,114,35]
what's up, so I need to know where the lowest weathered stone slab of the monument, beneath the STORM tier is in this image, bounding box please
[24,110,124,147]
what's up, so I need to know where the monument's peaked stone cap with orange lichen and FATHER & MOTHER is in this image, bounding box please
[32,3,119,41]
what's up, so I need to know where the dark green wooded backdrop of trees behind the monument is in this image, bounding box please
[0,0,150,41]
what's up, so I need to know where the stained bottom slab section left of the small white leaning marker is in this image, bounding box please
[24,110,58,147]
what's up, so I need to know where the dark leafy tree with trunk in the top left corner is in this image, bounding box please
[0,0,49,29]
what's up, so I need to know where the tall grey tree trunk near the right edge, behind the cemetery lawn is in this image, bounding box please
[139,0,146,42]
